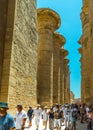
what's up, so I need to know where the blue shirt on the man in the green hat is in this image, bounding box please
[0,113,15,130]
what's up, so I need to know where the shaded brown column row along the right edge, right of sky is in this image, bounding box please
[79,0,93,104]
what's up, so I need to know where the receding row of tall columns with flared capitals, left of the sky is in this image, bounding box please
[37,8,70,105]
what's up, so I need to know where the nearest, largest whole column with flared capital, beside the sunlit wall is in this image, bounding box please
[37,8,60,105]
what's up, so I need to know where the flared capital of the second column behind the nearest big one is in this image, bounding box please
[53,32,66,47]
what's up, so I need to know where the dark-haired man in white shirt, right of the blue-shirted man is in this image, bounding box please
[15,104,27,130]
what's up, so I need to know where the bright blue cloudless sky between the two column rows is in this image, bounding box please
[37,0,82,98]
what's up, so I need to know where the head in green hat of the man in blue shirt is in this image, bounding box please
[0,102,8,116]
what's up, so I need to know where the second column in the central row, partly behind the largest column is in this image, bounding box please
[53,33,65,104]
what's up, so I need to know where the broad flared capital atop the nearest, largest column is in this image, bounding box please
[37,8,61,32]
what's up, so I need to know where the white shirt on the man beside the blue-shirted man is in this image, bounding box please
[15,110,27,129]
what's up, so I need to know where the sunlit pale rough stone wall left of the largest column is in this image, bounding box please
[9,0,37,111]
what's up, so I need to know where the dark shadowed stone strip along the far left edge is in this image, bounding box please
[0,0,7,95]
